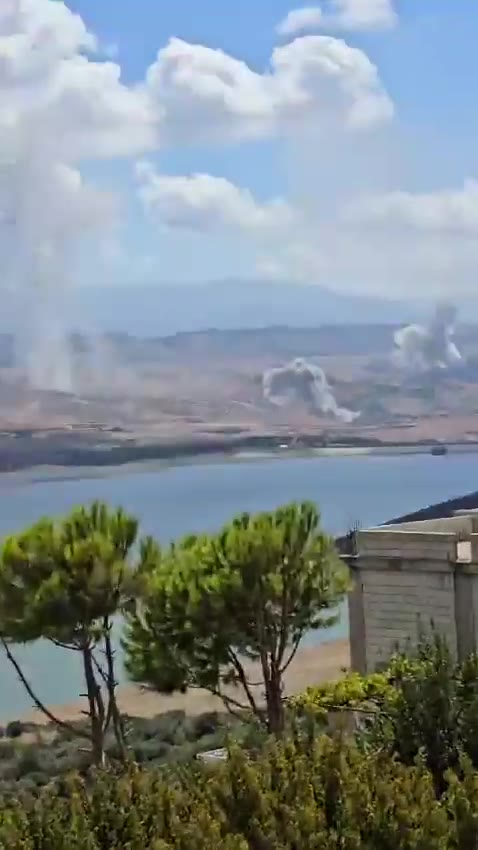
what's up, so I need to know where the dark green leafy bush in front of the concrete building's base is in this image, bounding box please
[291,633,478,790]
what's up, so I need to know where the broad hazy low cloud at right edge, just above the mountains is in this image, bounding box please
[261,200,478,297]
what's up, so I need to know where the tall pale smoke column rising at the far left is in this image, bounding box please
[0,153,113,392]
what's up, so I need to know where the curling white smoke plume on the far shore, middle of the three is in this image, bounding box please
[262,357,360,423]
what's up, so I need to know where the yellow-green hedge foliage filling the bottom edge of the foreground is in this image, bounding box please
[0,738,478,850]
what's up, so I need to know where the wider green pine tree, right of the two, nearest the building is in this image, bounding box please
[124,502,348,733]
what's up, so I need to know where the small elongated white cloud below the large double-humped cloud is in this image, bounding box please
[136,162,294,237]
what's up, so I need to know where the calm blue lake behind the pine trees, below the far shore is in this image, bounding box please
[0,454,478,718]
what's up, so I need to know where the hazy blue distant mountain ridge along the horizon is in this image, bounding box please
[0,279,456,336]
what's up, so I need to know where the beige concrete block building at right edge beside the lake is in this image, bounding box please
[346,512,478,673]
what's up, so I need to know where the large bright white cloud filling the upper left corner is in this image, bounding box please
[0,0,155,160]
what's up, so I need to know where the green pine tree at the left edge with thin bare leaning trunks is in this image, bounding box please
[0,502,138,765]
